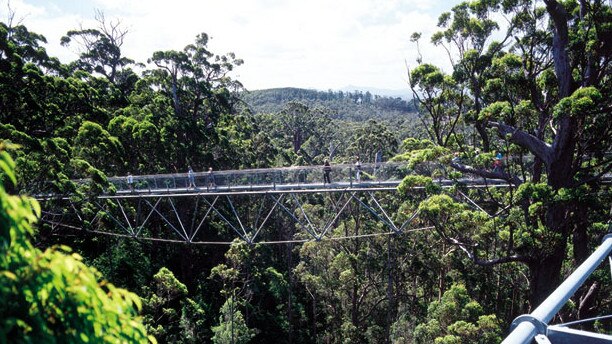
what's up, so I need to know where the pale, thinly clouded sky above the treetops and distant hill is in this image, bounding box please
[0,0,459,91]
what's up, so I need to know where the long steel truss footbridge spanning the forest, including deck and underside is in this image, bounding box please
[36,163,508,244]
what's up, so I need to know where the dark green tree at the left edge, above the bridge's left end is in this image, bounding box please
[0,23,113,191]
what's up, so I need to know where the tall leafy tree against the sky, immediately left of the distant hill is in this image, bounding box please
[145,33,242,168]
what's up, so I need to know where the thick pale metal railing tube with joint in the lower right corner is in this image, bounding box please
[502,234,612,344]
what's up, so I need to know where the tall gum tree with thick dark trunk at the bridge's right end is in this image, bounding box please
[411,0,612,306]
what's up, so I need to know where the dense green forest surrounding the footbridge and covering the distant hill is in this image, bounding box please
[0,0,612,343]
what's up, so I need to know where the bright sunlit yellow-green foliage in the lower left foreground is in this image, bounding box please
[0,150,155,343]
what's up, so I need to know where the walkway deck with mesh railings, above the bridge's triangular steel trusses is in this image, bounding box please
[35,162,507,201]
